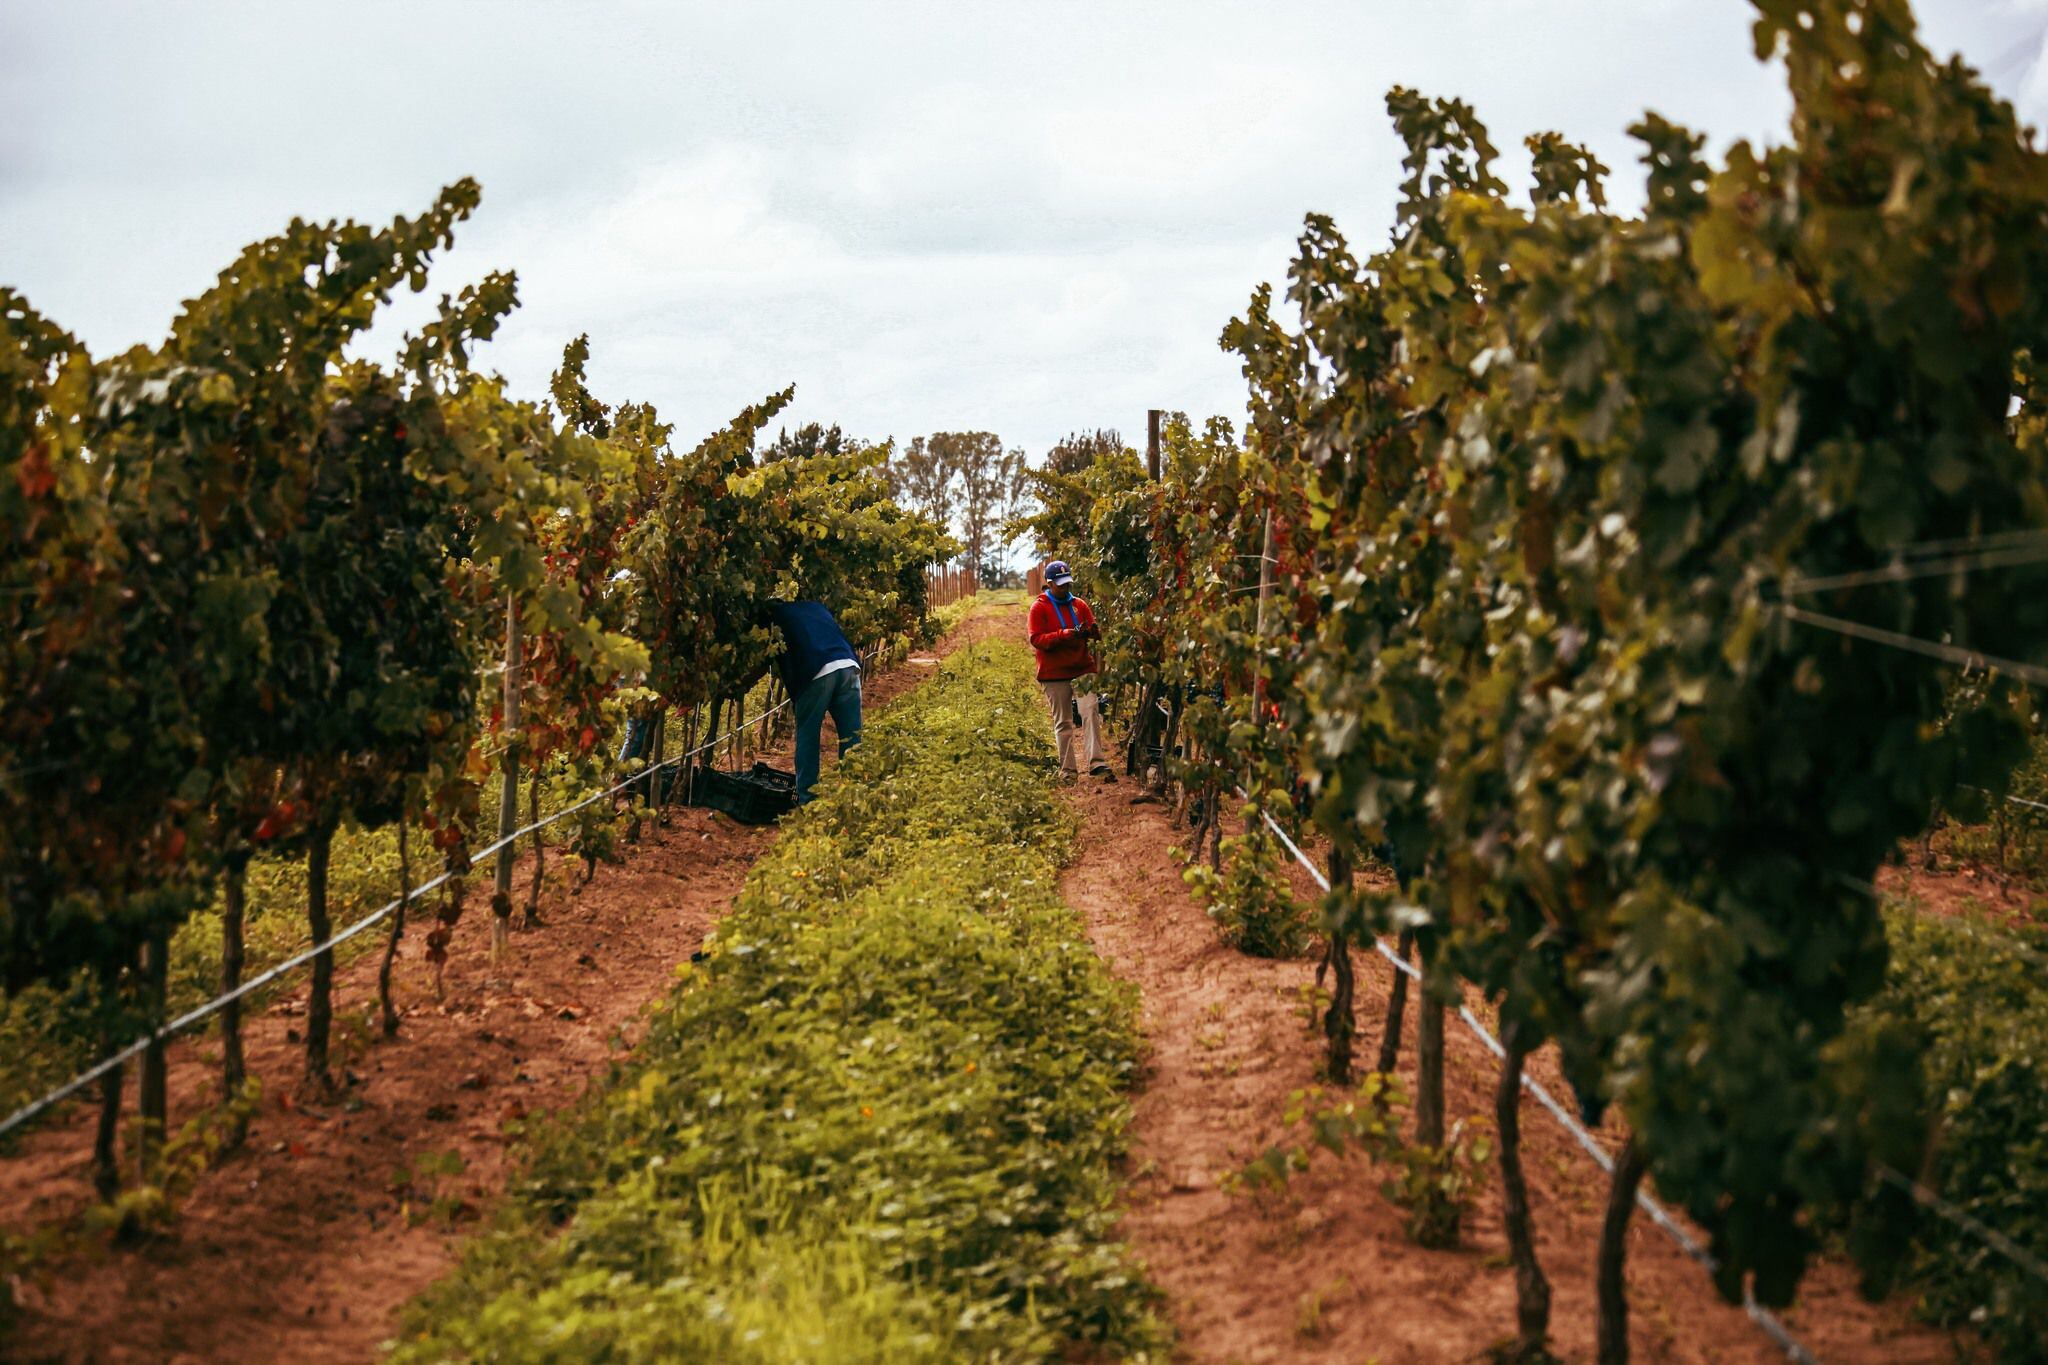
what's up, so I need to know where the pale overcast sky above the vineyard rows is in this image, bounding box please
[0,0,2048,456]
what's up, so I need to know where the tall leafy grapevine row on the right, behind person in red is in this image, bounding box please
[1034,0,2048,1361]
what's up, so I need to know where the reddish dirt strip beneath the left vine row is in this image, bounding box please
[0,614,1006,1361]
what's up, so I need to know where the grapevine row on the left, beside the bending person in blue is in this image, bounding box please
[0,180,956,1195]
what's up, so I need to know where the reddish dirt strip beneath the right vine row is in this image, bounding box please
[1061,780,1954,1365]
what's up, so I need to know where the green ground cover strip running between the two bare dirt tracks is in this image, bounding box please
[393,641,1163,1361]
